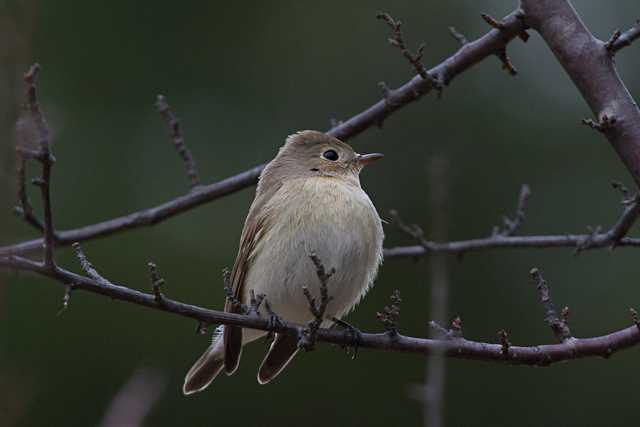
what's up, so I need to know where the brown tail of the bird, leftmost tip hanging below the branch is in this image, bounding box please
[182,326,224,395]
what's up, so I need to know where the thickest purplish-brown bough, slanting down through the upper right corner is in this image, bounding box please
[521,0,640,185]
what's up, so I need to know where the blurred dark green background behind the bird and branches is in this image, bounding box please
[0,0,640,426]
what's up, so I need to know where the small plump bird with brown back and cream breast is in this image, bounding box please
[183,130,384,395]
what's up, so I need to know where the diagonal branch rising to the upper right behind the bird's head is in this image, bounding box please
[0,12,524,256]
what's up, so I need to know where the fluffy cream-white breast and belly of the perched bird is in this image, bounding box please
[243,178,383,323]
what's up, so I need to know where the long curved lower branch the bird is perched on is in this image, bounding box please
[0,257,640,366]
